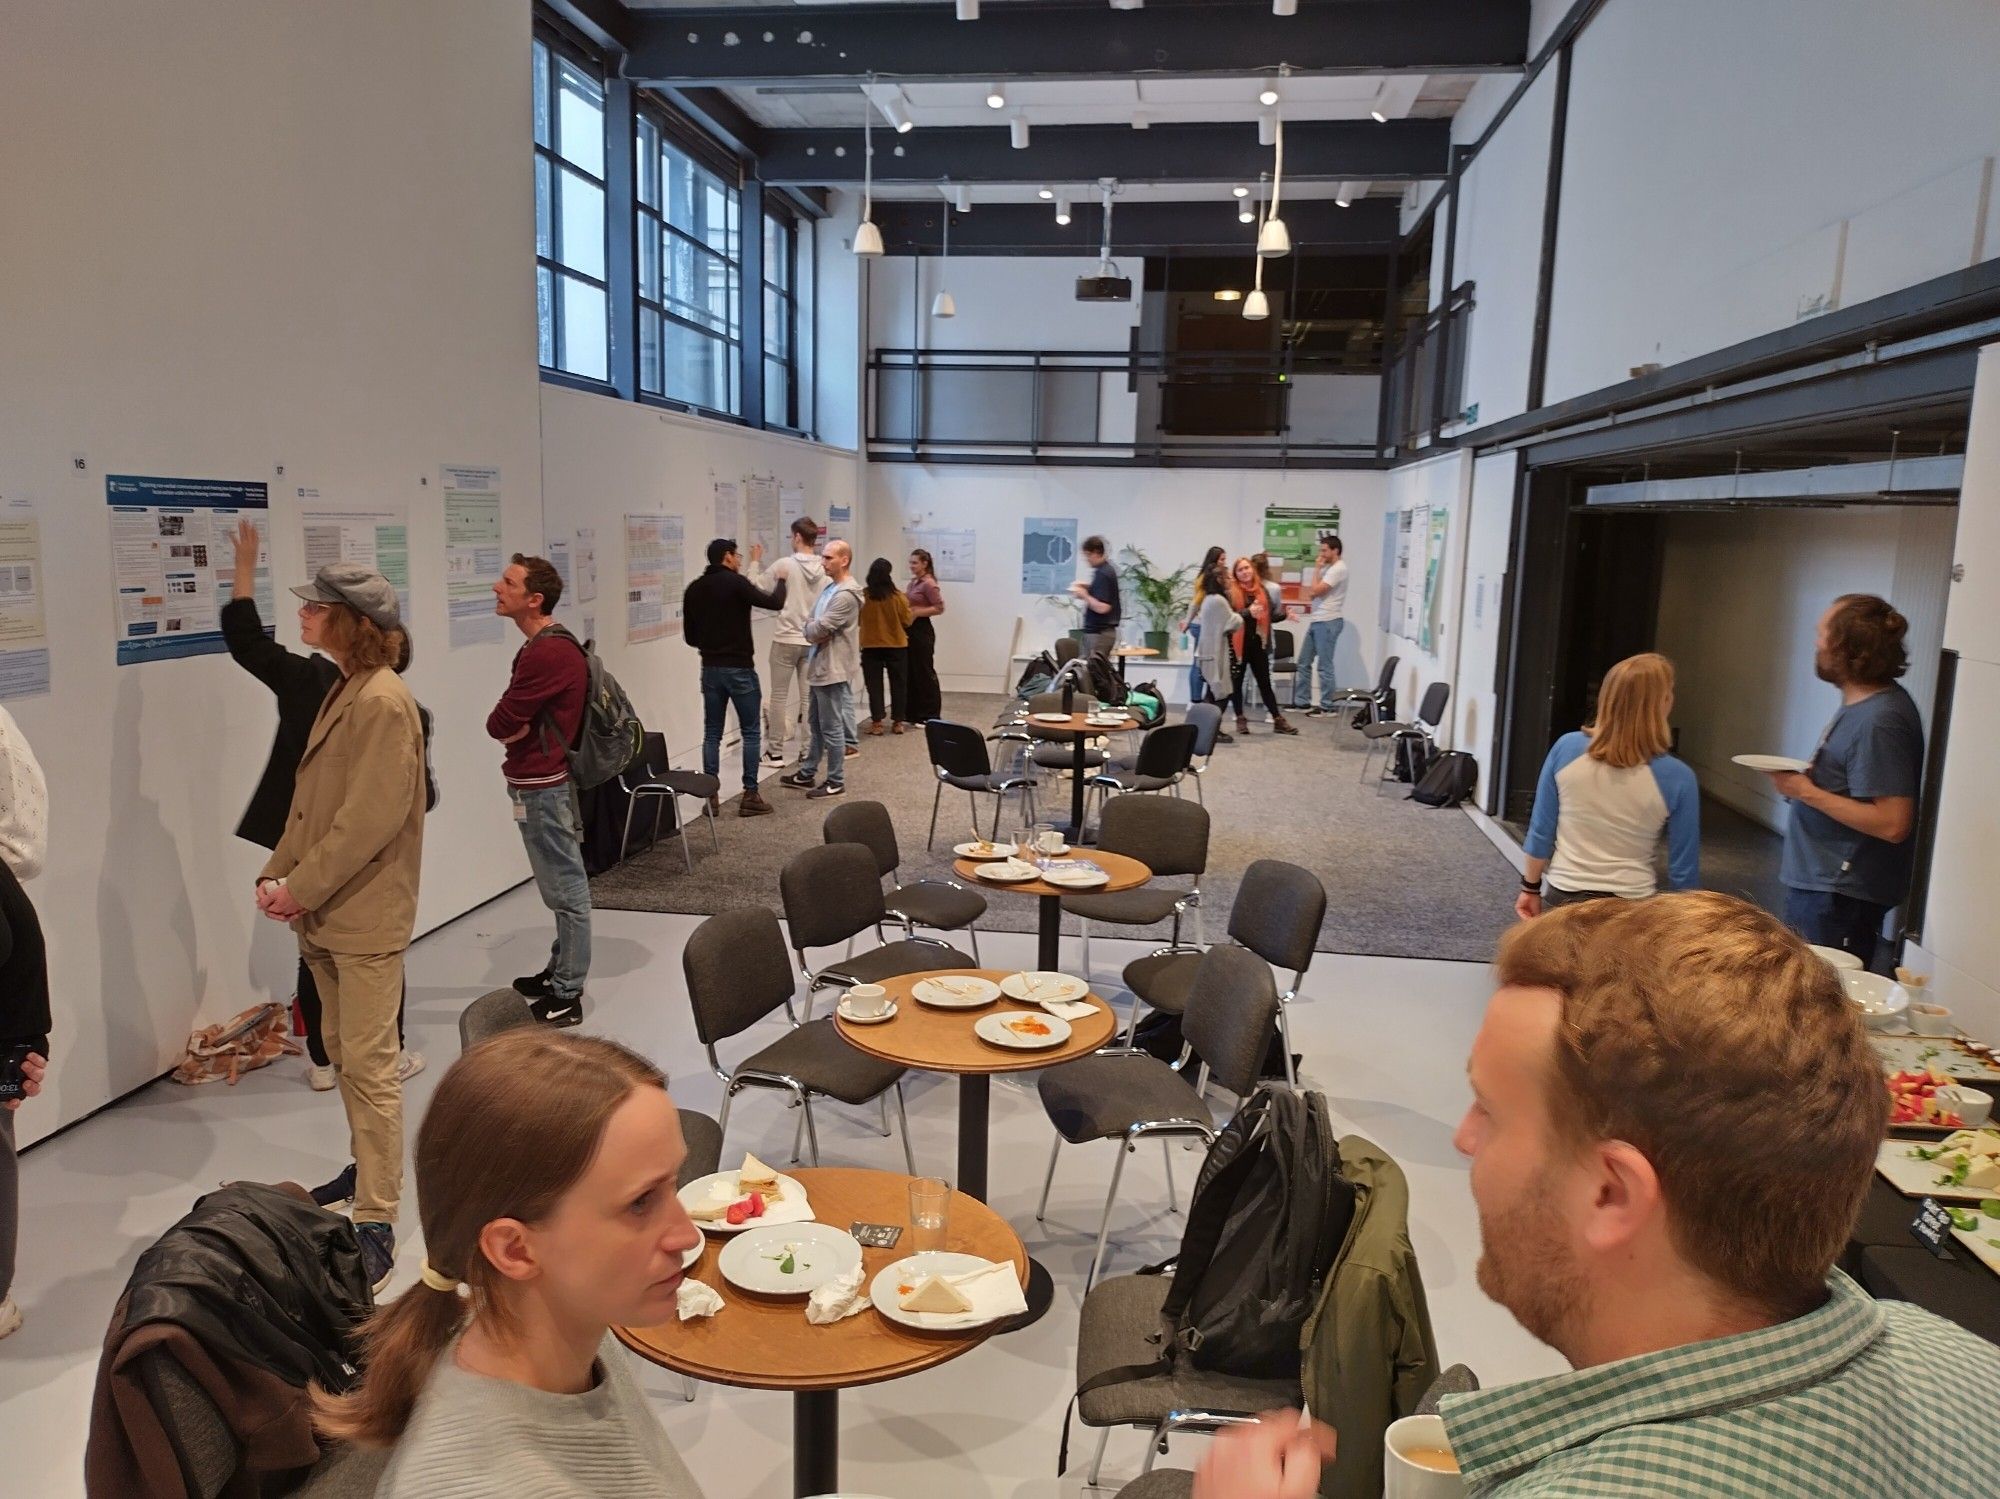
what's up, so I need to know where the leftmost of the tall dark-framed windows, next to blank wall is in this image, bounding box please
[534,38,610,380]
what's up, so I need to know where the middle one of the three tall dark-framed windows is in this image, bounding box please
[638,116,742,416]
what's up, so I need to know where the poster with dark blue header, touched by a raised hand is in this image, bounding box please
[104,474,272,666]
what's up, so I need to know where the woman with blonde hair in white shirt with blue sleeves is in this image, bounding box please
[1514,652,1702,921]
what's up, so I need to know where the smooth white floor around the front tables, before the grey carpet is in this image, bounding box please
[0,887,1564,1499]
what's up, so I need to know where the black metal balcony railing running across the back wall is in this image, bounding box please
[868,348,1382,466]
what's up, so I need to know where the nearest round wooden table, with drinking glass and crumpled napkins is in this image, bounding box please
[612,1165,1028,1497]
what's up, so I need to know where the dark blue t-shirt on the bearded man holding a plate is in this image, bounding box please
[1780,684,1924,905]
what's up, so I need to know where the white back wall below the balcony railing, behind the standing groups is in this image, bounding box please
[866,464,1388,692]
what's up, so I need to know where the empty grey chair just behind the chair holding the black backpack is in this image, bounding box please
[1034,951,1278,1289]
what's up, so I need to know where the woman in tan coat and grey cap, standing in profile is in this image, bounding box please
[256,564,424,1291]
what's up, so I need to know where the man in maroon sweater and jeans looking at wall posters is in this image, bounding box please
[486,552,590,1025]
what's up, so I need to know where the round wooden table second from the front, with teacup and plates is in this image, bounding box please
[834,975,1118,1201]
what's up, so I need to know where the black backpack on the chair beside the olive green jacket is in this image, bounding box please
[1058,1087,1354,1471]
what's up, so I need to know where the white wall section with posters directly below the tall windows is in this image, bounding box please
[542,386,860,763]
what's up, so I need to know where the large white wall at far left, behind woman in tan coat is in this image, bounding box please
[0,0,540,1139]
